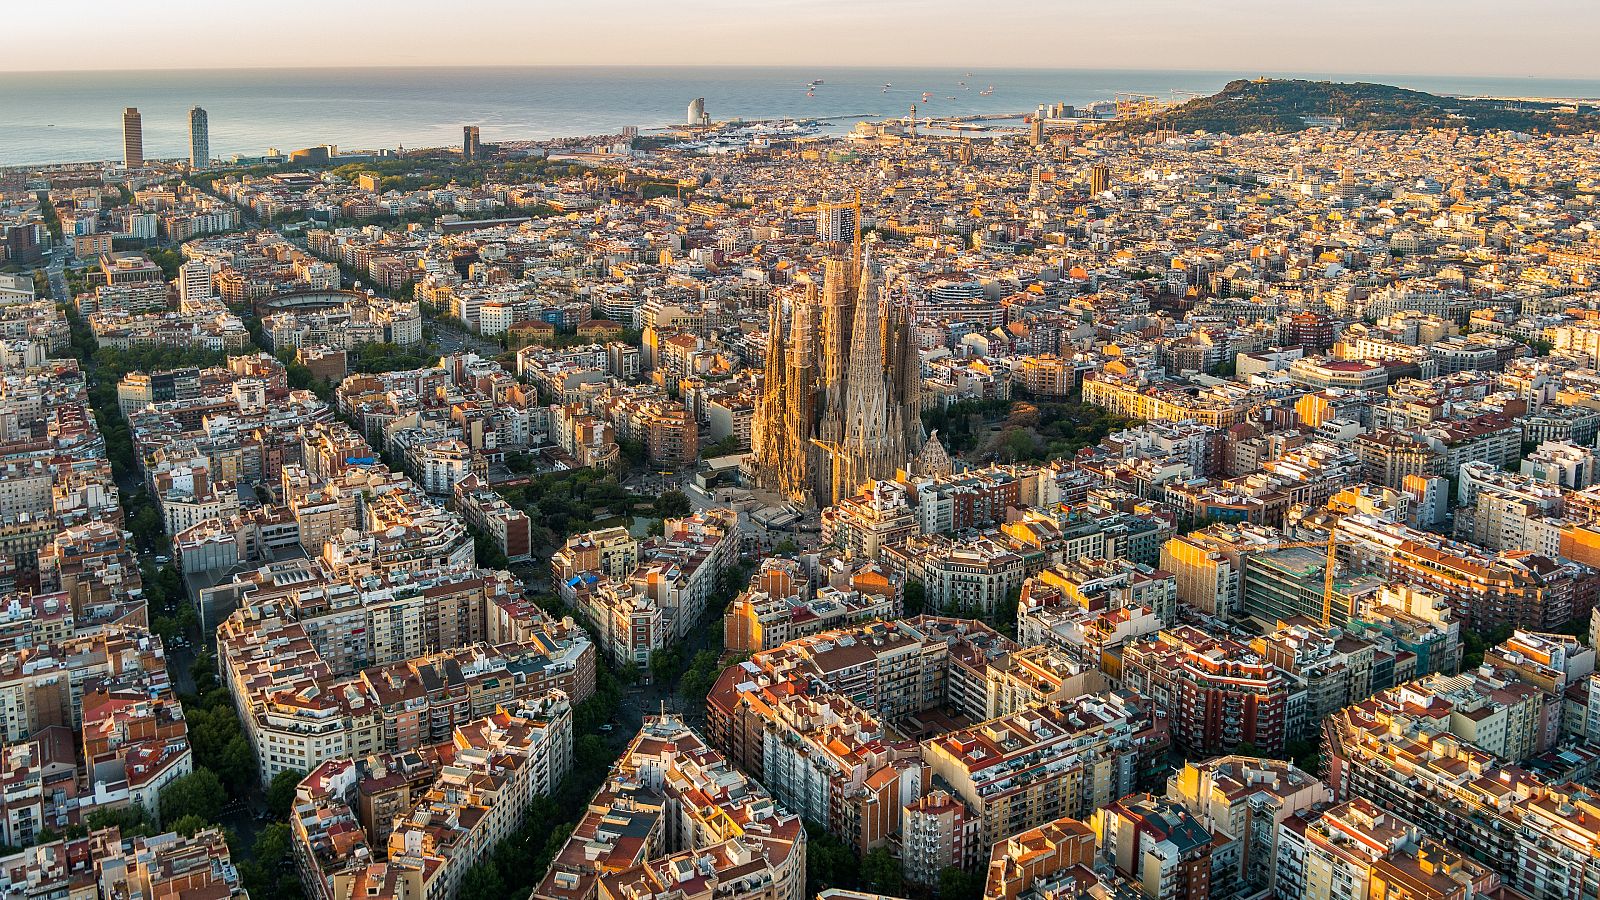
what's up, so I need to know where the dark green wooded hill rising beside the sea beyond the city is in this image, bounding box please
[1128,78,1600,135]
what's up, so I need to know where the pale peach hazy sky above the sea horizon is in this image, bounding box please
[12,0,1600,76]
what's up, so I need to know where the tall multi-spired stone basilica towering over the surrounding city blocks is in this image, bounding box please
[750,245,950,506]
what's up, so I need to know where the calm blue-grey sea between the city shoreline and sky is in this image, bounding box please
[0,66,1600,167]
